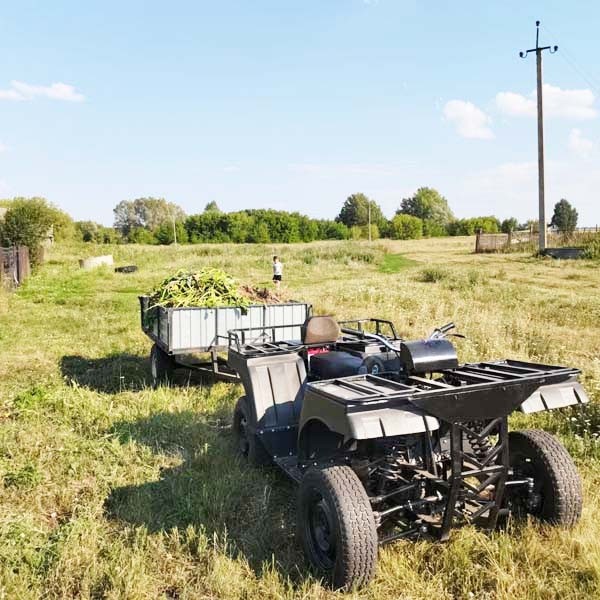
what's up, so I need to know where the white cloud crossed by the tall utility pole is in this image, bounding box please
[496,83,598,120]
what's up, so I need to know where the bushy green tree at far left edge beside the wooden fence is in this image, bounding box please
[0,198,70,264]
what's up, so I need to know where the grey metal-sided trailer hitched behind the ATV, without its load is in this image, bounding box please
[139,296,312,385]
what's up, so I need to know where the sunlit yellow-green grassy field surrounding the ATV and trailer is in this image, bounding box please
[0,238,600,600]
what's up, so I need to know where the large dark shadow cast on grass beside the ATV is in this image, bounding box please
[105,411,305,581]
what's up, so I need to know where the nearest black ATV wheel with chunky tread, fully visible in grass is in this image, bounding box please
[298,466,377,590]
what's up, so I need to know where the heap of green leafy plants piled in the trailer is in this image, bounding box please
[150,269,250,308]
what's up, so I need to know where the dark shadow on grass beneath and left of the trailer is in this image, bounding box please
[60,353,207,394]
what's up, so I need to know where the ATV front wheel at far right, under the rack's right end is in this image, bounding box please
[506,429,583,527]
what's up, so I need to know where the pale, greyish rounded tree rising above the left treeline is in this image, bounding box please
[113,198,185,236]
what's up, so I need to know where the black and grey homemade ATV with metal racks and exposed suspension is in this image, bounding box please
[228,317,588,589]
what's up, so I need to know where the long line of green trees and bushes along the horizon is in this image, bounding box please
[0,187,577,262]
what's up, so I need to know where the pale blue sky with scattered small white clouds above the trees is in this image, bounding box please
[0,0,600,226]
